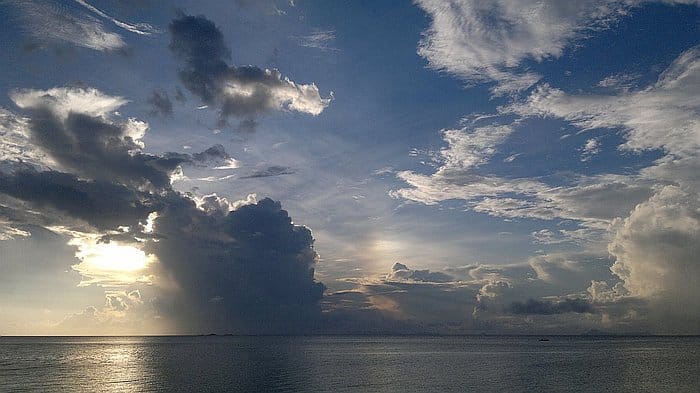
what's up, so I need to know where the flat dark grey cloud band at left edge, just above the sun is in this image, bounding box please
[0,170,156,230]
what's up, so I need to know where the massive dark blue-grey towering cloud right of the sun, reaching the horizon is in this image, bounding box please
[147,194,324,333]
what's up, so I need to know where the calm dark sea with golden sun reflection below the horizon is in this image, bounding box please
[0,337,700,392]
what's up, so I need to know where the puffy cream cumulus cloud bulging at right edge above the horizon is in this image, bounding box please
[608,186,700,331]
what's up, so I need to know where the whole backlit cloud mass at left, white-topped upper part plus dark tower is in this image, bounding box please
[0,88,324,333]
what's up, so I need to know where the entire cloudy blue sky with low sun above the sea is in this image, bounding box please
[0,0,700,335]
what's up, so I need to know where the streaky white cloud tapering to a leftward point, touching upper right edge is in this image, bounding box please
[503,47,700,158]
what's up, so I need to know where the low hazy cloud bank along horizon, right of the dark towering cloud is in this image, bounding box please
[330,253,620,334]
